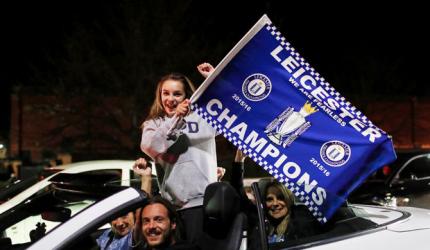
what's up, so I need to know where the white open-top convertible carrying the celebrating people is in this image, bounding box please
[2,184,430,250]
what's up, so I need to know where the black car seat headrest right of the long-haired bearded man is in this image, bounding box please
[203,182,240,236]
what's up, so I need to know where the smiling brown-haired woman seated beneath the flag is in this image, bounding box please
[263,180,294,243]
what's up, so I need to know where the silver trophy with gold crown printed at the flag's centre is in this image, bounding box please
[264,102,318,148]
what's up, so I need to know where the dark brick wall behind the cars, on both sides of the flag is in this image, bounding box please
[10,94,430,162]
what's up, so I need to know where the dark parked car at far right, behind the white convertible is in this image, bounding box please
[349,153,430,209]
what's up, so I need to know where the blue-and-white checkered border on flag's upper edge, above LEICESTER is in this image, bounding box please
[266,24,387,137]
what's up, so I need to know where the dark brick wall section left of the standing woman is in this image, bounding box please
[10,94,140,162]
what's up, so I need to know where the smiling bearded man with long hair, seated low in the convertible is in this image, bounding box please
[133,196,200,250]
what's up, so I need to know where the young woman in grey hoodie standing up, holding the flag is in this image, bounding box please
[141,63,217,241]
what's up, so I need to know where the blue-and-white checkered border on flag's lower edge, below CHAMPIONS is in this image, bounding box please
[191,103,327,223]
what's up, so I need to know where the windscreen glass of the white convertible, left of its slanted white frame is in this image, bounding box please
[0,184,123,249]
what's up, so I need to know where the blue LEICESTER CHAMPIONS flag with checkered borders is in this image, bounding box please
[191,15,396,222]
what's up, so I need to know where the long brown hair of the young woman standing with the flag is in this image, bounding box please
[142,73,196,124]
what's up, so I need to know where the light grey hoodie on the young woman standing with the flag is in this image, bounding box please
[140,112,217,208]
